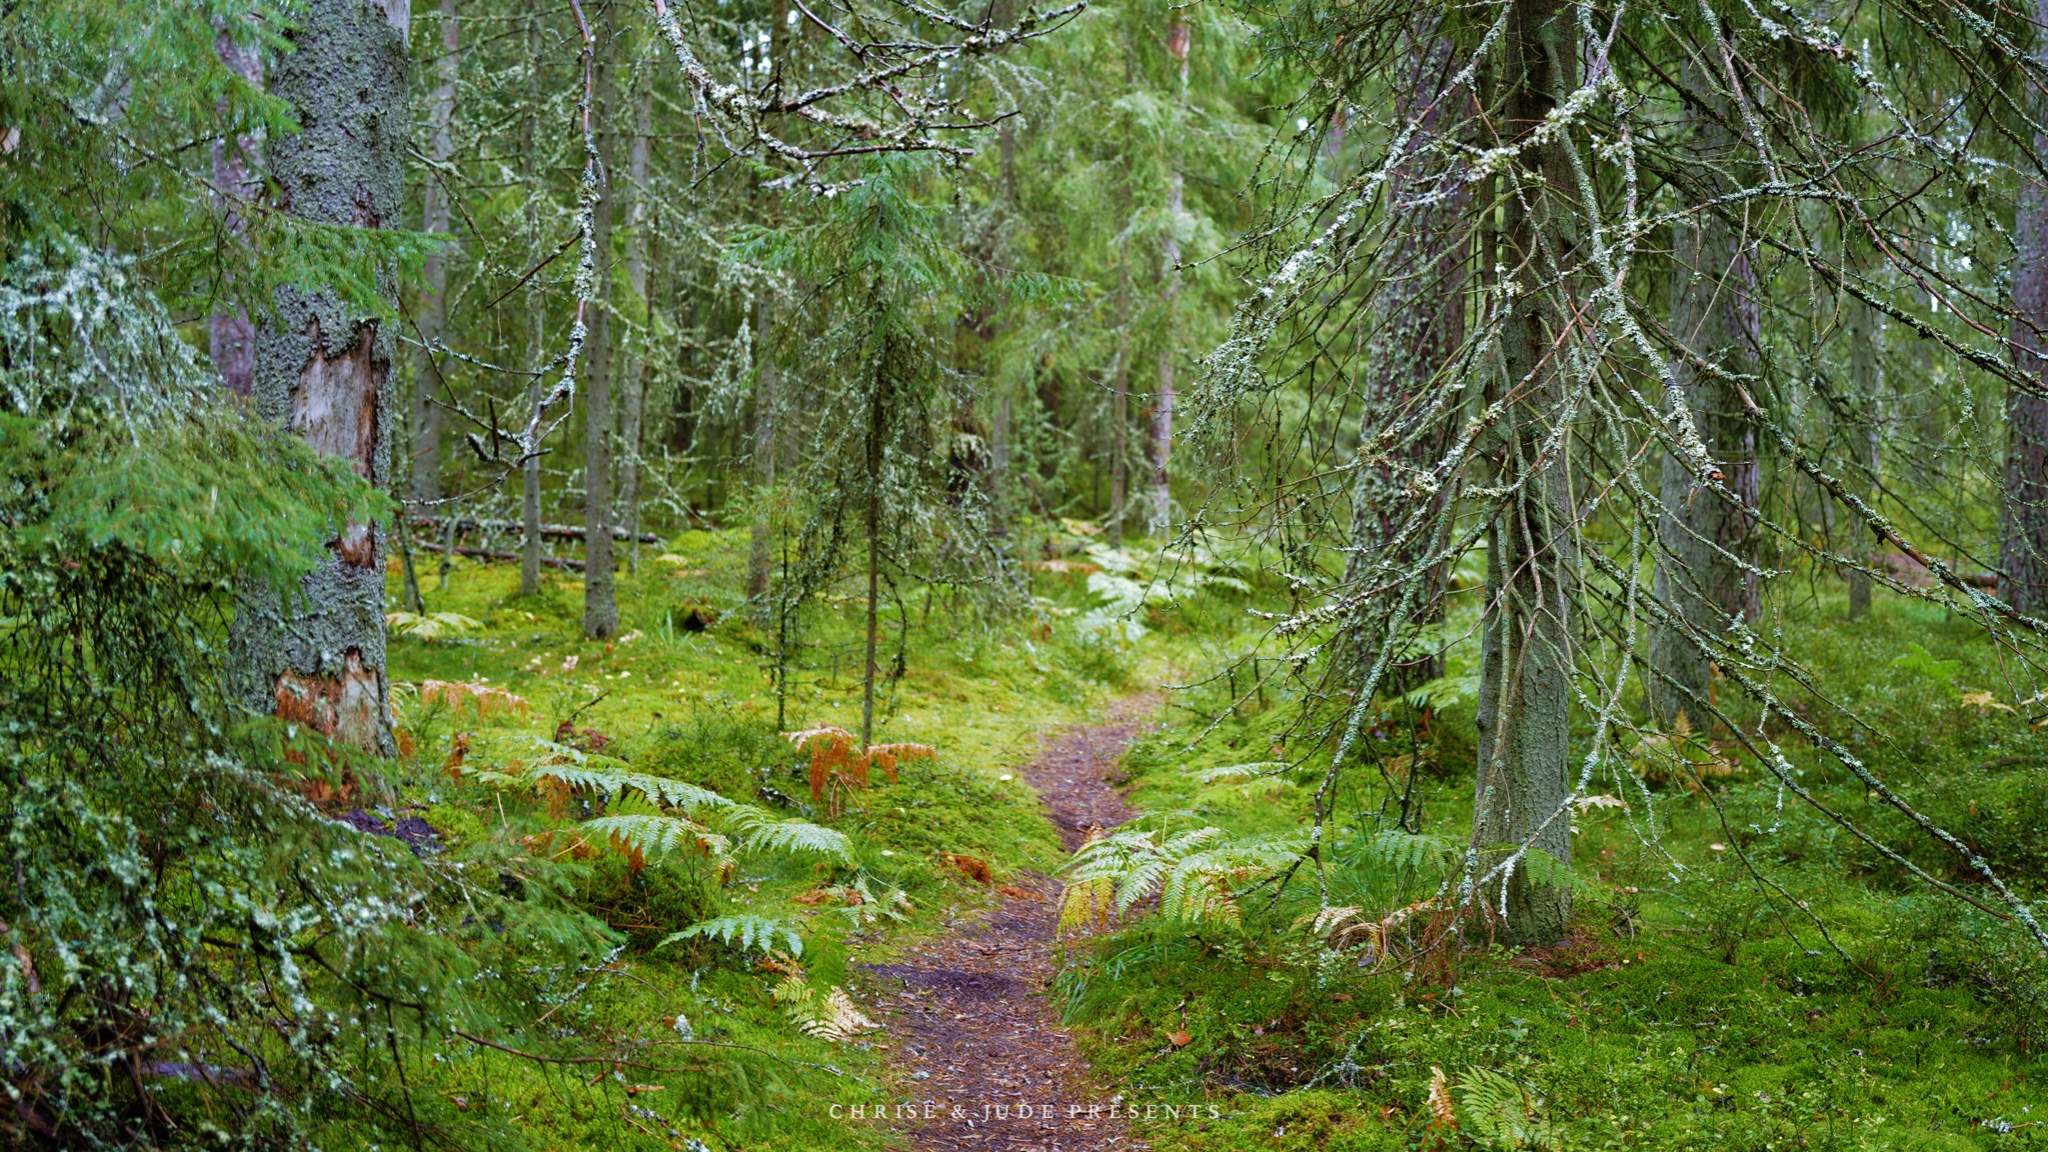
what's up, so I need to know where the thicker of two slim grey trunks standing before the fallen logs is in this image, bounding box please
[584,8,618,640]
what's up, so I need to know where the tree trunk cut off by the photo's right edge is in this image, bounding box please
[1999,11,2048,615]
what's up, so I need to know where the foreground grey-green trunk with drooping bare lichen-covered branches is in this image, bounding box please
[1473,0,1577,941]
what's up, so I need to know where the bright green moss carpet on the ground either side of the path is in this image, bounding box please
[376,533,2048,1152]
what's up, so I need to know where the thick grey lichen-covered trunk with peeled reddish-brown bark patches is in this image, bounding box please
[236,0,408,754]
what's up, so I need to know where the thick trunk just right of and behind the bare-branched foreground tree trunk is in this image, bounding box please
[1649,72,1761,732]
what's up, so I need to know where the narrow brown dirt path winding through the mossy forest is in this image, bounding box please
[864,695,1159,1152]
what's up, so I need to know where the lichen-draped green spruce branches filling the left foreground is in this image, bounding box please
[0,244,608,1146]
